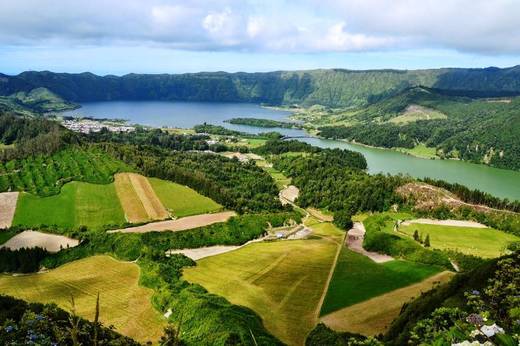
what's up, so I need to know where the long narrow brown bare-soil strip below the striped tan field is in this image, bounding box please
[108,211,236,233]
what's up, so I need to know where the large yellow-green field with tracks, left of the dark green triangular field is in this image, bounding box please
[184,234,338,345]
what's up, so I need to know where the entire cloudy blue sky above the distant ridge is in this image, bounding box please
[0,0,520,75]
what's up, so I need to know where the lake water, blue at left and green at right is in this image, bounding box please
[66,101,520,200]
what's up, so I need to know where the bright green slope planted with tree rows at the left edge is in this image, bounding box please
[0,146,131,196]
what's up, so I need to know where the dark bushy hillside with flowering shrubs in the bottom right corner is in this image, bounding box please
[384,253,520,345]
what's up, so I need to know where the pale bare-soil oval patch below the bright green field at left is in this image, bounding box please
[2,231,79,252]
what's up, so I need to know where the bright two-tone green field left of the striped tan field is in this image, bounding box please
[13,182,125,229]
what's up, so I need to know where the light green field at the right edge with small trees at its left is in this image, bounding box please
[399,224,520,258]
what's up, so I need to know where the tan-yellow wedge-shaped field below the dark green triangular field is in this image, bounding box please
[321,271,455,336]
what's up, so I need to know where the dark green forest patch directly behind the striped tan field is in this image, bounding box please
[100,144,282,213]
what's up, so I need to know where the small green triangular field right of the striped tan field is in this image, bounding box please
[148,178,222,217]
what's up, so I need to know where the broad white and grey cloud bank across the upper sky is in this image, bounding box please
[0,0,520,54]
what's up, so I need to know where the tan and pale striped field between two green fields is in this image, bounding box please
[114,173,169,223]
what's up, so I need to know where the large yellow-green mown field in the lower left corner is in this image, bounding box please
[0,256,165,342]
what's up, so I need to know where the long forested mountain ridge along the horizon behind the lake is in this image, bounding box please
[0,66,520,107]
